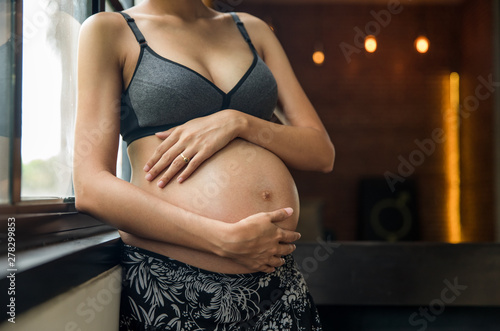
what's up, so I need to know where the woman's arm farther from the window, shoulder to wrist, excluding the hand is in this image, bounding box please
[237,13,335,172]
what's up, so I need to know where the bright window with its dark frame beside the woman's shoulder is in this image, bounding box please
[0,0,104,217]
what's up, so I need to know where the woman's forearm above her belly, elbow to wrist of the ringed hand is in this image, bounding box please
[235,112,335,172]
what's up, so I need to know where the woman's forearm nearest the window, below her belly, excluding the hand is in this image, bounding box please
[75,171,227,254]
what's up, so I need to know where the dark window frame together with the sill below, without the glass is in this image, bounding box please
[0,0,120,321]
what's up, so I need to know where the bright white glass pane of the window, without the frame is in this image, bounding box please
[21,0,89,200]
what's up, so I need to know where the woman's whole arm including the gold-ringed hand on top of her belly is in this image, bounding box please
[144,13,335,187]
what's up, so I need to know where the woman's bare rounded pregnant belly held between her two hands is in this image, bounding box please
[122,136,299,273]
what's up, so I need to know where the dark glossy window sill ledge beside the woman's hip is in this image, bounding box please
[0,212,119,321]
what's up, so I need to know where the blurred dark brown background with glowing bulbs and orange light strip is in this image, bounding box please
[228,0,500,242]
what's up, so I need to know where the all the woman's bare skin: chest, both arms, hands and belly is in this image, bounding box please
[74,0,334,273]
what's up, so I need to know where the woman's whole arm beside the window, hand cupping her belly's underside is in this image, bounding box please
[74,13,300,272]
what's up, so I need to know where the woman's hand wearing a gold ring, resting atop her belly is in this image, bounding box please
[144,109,241,188]
